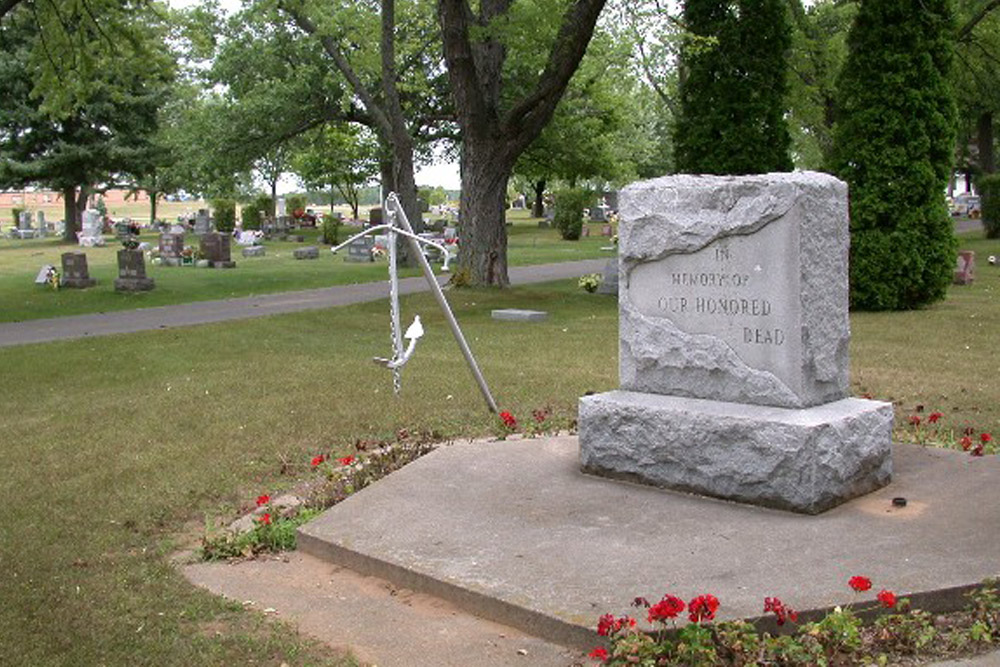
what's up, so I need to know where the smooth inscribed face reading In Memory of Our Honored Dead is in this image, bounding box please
[626,219,802,391]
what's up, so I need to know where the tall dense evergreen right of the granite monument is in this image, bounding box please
[832,0,956,310]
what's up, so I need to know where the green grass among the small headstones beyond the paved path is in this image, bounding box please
[0,212,611,322]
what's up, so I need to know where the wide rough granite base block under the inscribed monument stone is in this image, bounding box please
[579,391,893,514]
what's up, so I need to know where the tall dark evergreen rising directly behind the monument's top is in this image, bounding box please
[674,0,792,174]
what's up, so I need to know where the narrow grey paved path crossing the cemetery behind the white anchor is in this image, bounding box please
[0,259,607,347]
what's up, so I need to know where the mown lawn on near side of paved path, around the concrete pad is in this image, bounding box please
[0,226,1000,666]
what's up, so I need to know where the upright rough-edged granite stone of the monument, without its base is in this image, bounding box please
[618,172,850,408]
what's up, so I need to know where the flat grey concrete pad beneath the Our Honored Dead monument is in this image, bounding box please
[299,436,1000,648]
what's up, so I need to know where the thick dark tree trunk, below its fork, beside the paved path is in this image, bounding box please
[459,138,514,287]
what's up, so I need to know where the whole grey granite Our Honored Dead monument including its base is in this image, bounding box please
[579,172,892,514]
